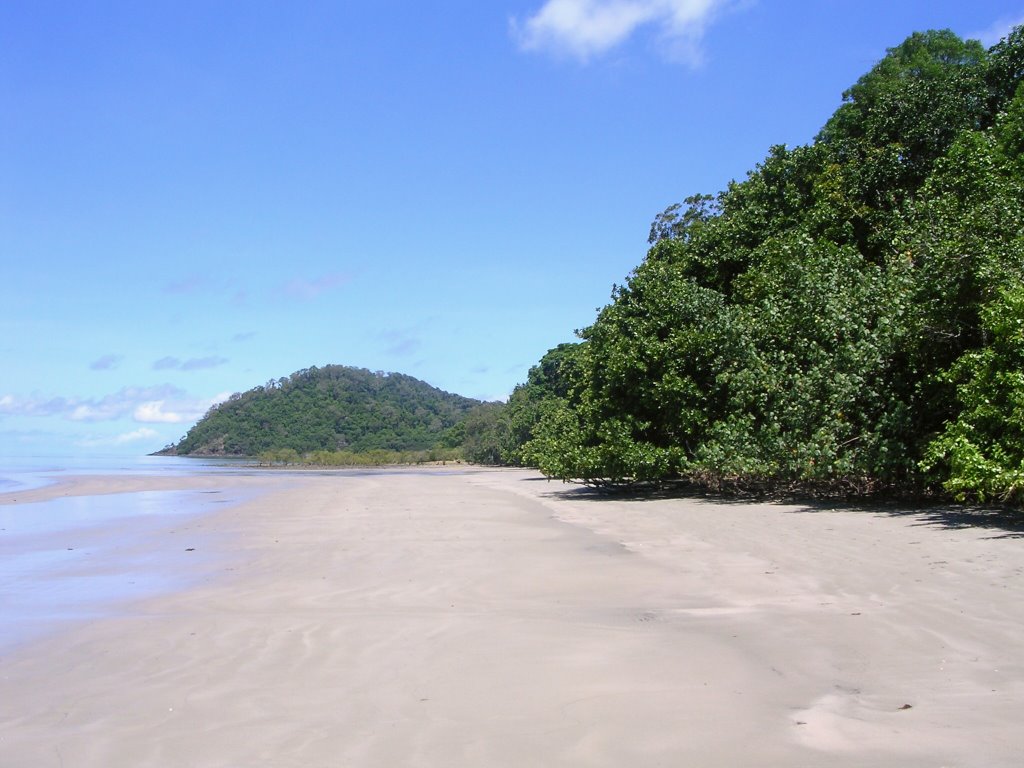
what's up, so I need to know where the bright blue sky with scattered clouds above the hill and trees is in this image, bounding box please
[0,0,1024,457]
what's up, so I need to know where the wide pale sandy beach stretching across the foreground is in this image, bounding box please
[0,468,1024,768]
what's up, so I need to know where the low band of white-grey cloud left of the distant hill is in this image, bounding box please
[0,384,229,424]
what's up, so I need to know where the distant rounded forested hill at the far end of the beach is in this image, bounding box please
[162,366,481,456]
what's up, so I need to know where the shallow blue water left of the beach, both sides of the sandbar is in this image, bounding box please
[0,457,253,652]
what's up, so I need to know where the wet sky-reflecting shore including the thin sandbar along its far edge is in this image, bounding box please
[0,475,288,655]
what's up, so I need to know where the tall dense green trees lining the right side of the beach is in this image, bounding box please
[494,29,1024,500]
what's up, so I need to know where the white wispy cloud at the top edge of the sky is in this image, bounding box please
[510,0,729,65]
